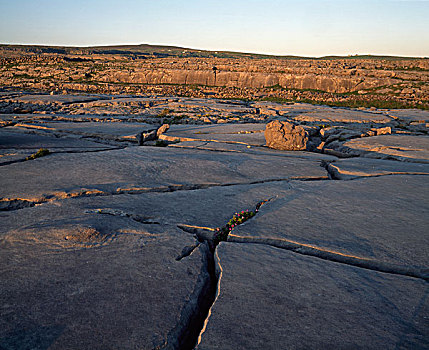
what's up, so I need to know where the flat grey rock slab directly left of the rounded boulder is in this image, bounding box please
[164,123,265,146]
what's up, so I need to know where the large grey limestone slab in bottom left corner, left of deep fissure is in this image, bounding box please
[0,198,209,349]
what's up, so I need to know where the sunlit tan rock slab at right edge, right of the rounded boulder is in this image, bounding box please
[342,135,429,163]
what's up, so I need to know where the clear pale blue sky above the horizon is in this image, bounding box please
[0,0,429,57]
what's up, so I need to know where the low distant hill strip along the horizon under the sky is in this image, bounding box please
[0,44,420,60]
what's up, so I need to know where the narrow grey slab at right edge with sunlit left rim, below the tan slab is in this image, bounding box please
[328,157,429,180]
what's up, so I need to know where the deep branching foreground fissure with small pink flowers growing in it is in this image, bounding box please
[171,197,429,350]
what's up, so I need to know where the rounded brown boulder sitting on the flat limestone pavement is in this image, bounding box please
[265,120,309,151]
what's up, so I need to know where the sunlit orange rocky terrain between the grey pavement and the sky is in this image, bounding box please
[0,45,429,109]
